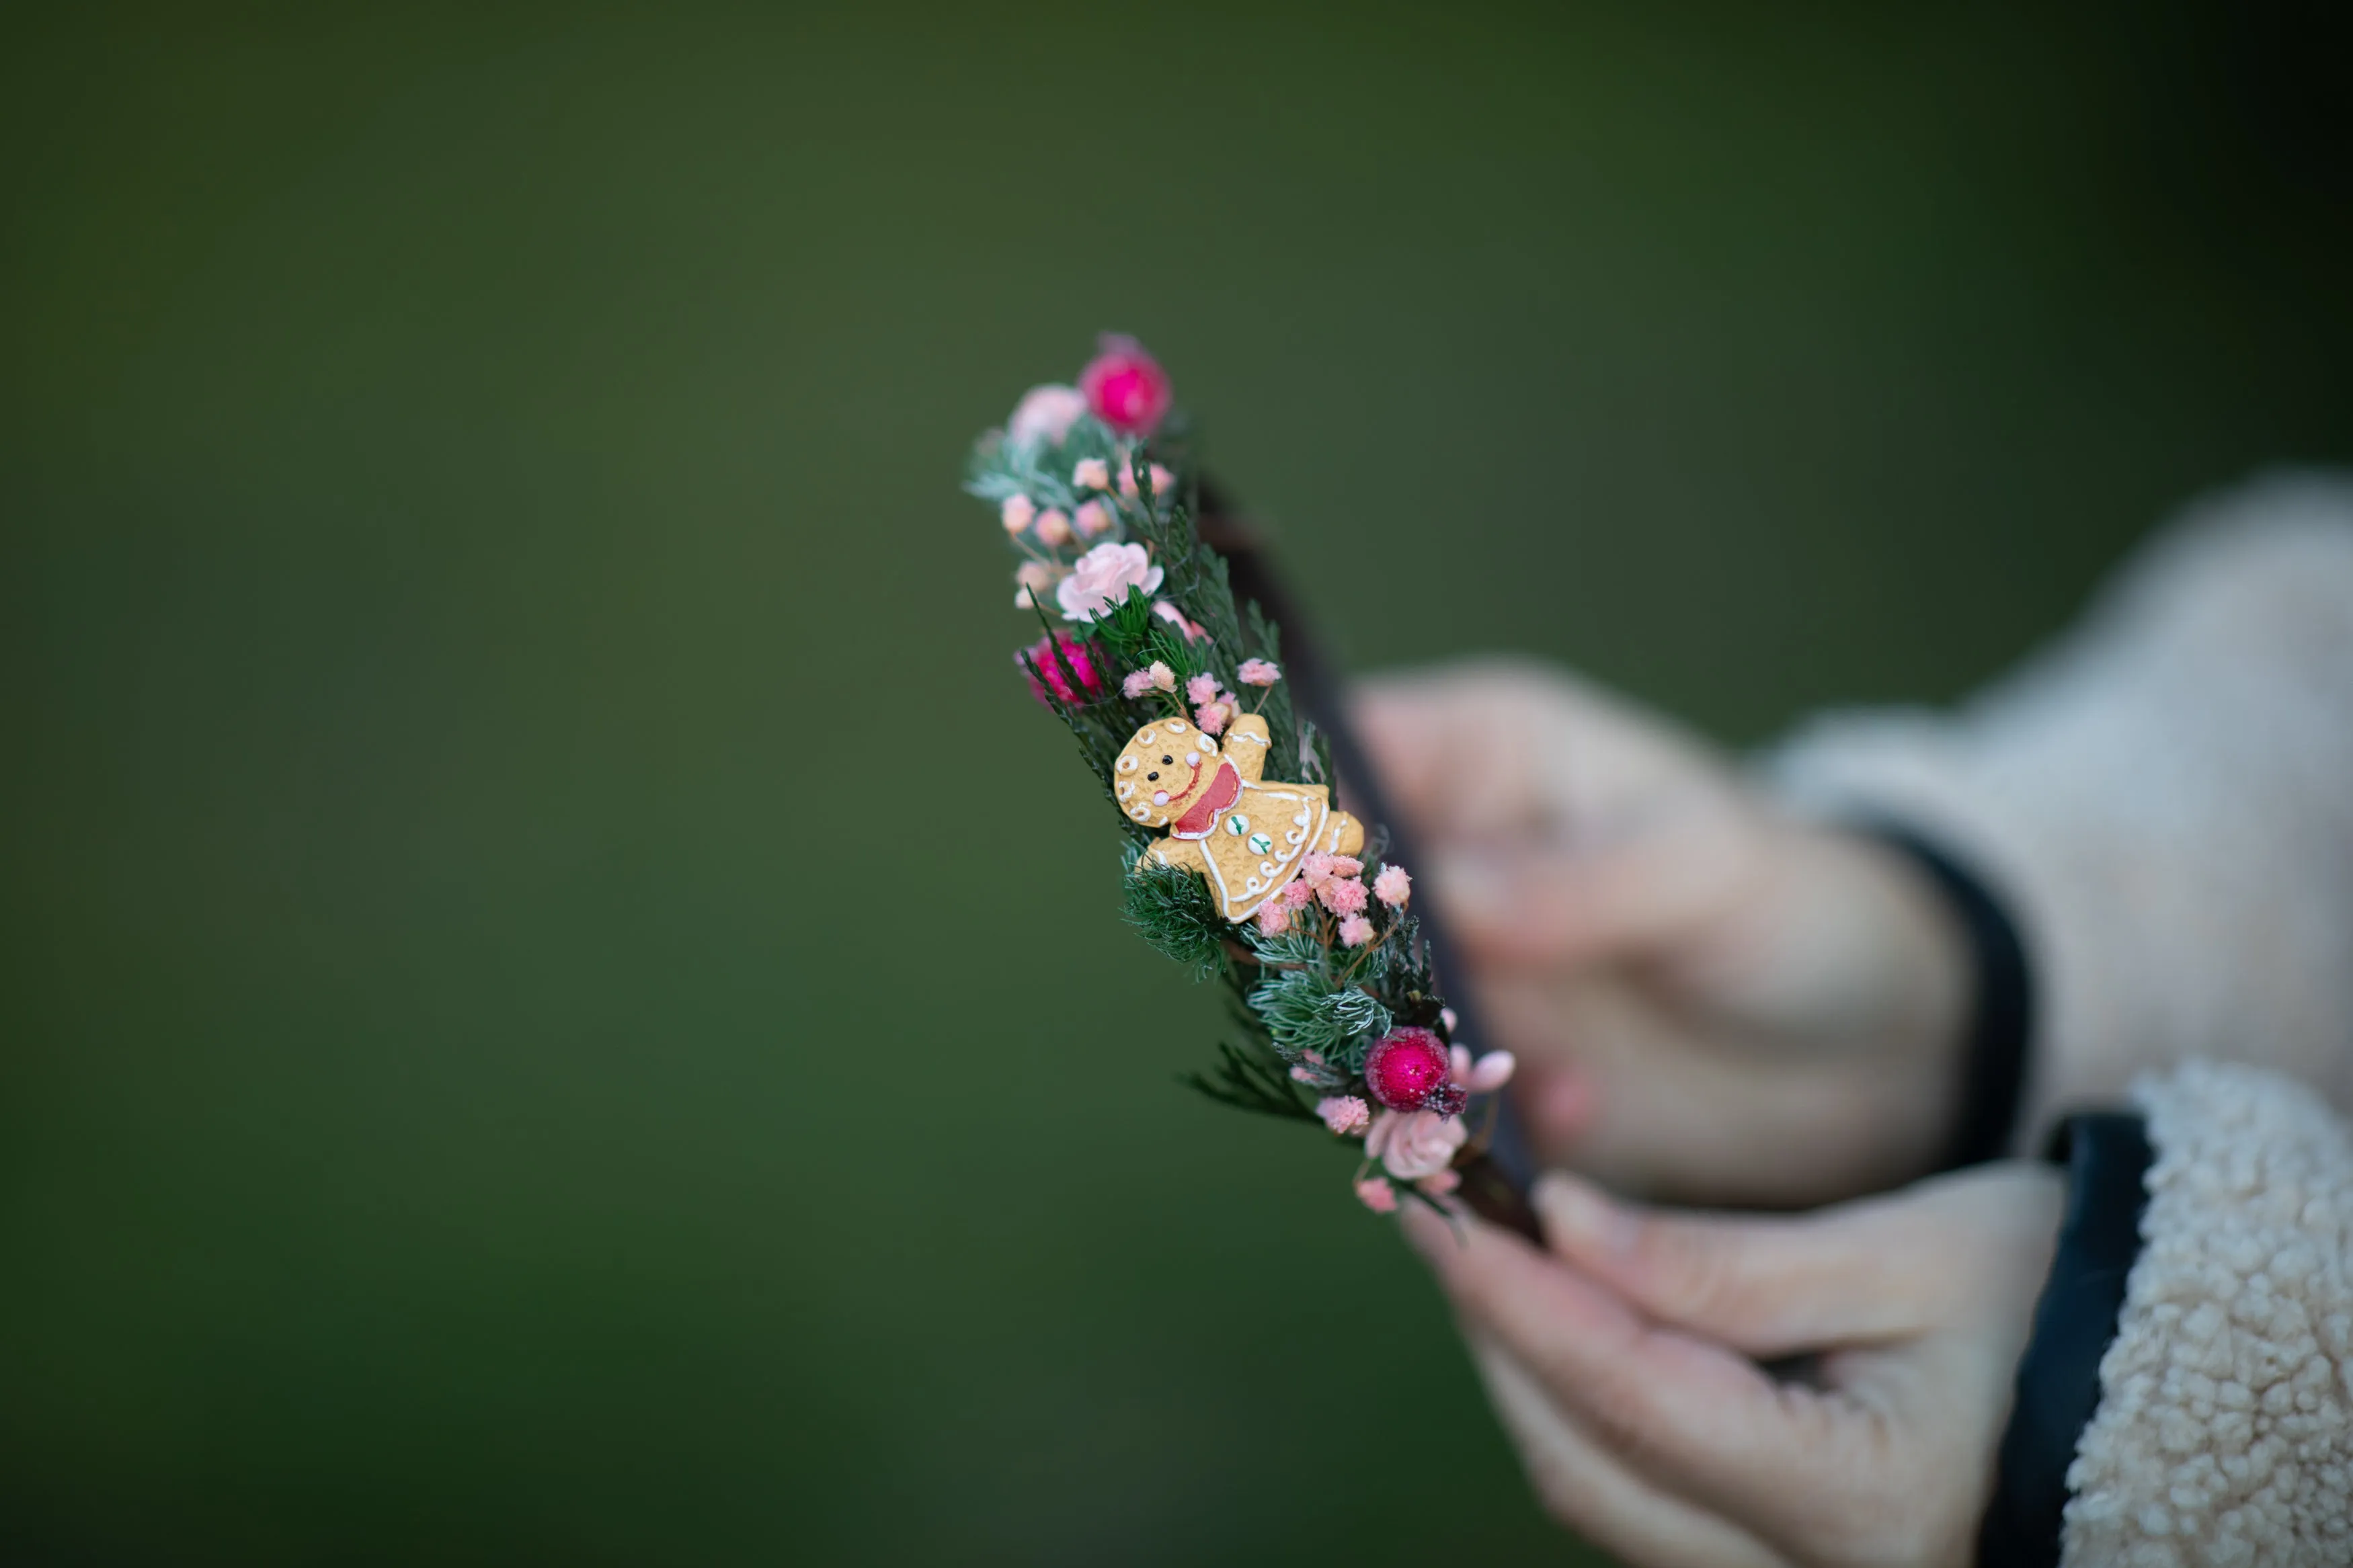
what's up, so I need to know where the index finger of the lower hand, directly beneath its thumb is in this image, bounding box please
[1402,1210,1835,1535]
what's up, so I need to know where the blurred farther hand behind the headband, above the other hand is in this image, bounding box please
[1355,663,1970,1206]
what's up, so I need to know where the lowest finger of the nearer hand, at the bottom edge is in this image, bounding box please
[1471,1333,1786,1568]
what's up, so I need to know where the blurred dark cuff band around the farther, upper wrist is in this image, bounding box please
[1862,823,2036,1171]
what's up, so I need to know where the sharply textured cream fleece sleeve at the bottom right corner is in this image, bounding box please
[2061,1063,2353,1568]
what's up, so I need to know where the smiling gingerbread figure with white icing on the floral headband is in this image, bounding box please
[1113,712,1365,919]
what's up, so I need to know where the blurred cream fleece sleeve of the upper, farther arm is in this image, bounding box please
[1767,475,2353,1147]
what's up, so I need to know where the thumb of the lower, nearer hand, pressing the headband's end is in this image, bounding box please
[1534,1173,1953,1356]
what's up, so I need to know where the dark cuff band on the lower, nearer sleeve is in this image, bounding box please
[1977,1112,2151,1568]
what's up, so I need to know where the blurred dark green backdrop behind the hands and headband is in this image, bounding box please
[0,2,2353,1563]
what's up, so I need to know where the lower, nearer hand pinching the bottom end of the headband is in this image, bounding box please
[1405,1163,2064,1568]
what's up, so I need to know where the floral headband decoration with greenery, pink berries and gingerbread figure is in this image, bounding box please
[965,334,1525,1213]
